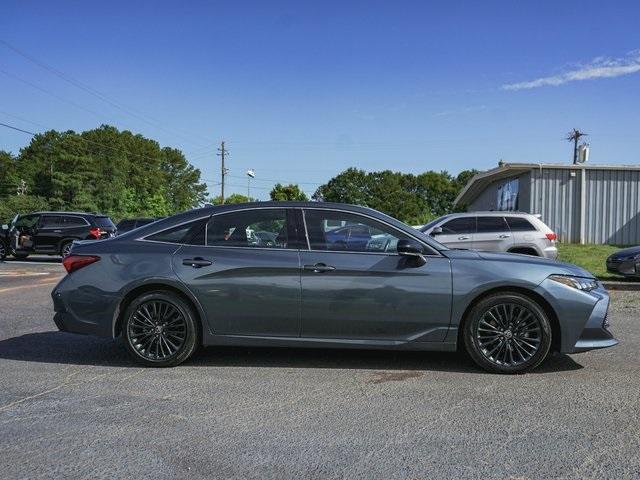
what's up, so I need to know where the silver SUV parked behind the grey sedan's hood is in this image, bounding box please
[419,212,558,259]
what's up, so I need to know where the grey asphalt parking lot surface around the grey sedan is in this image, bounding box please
[0,258,640,479]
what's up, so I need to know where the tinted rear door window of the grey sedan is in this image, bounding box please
[207,208,293,248]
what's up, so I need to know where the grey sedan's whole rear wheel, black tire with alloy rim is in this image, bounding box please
[122,290,200,367]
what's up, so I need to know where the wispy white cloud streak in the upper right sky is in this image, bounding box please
[502,50,640,90]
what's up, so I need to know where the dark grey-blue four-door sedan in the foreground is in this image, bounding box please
[52,202,617,373]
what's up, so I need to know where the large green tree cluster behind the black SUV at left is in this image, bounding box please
[0,125,207,221]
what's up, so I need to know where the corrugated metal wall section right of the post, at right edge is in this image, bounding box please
[585,169,640,245]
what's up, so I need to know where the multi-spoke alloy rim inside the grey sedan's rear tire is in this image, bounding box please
[127,300,187,361]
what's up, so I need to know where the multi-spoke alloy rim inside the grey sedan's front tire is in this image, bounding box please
[474,303,542,367]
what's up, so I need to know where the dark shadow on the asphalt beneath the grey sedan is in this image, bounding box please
[0,332,583,373]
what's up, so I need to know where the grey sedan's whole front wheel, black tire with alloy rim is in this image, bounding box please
[462,292,552,373]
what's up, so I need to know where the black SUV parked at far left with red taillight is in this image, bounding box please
[0,212,116,258]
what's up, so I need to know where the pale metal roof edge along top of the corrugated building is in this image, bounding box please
[453,163,640,205]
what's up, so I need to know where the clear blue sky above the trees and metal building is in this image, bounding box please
[0,0,640,199]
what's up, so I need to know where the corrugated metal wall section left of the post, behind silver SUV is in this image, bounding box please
[529,167,580,243]
